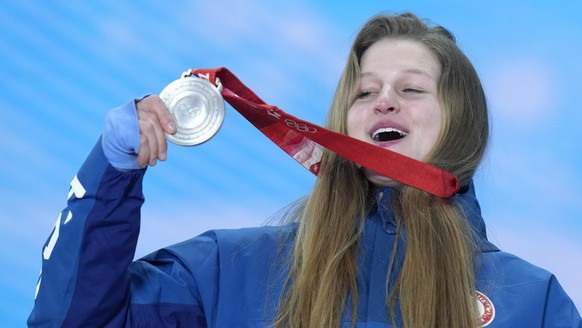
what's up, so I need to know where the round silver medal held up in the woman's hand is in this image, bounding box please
[160,73,225,146]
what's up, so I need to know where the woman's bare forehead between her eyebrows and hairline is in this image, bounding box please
[360,38,441,81]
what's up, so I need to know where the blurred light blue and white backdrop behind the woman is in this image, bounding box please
[0,0,582,327]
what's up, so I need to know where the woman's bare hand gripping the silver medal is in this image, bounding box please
[136,95,176,167]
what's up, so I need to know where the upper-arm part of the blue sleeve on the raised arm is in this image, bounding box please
[129,234,220,327]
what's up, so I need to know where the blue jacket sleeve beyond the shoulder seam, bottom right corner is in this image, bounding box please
[543,275,582,328]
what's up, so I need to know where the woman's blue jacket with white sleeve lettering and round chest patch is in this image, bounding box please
[28,142,582,328]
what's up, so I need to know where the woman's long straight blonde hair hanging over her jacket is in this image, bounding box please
[274,13,489,328]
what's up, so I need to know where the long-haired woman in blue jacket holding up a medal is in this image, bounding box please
[29,14,582,327]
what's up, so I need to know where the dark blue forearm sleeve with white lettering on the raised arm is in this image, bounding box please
[28,140,145,327]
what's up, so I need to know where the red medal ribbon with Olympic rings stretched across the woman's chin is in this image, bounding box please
[191,67,459,198]
